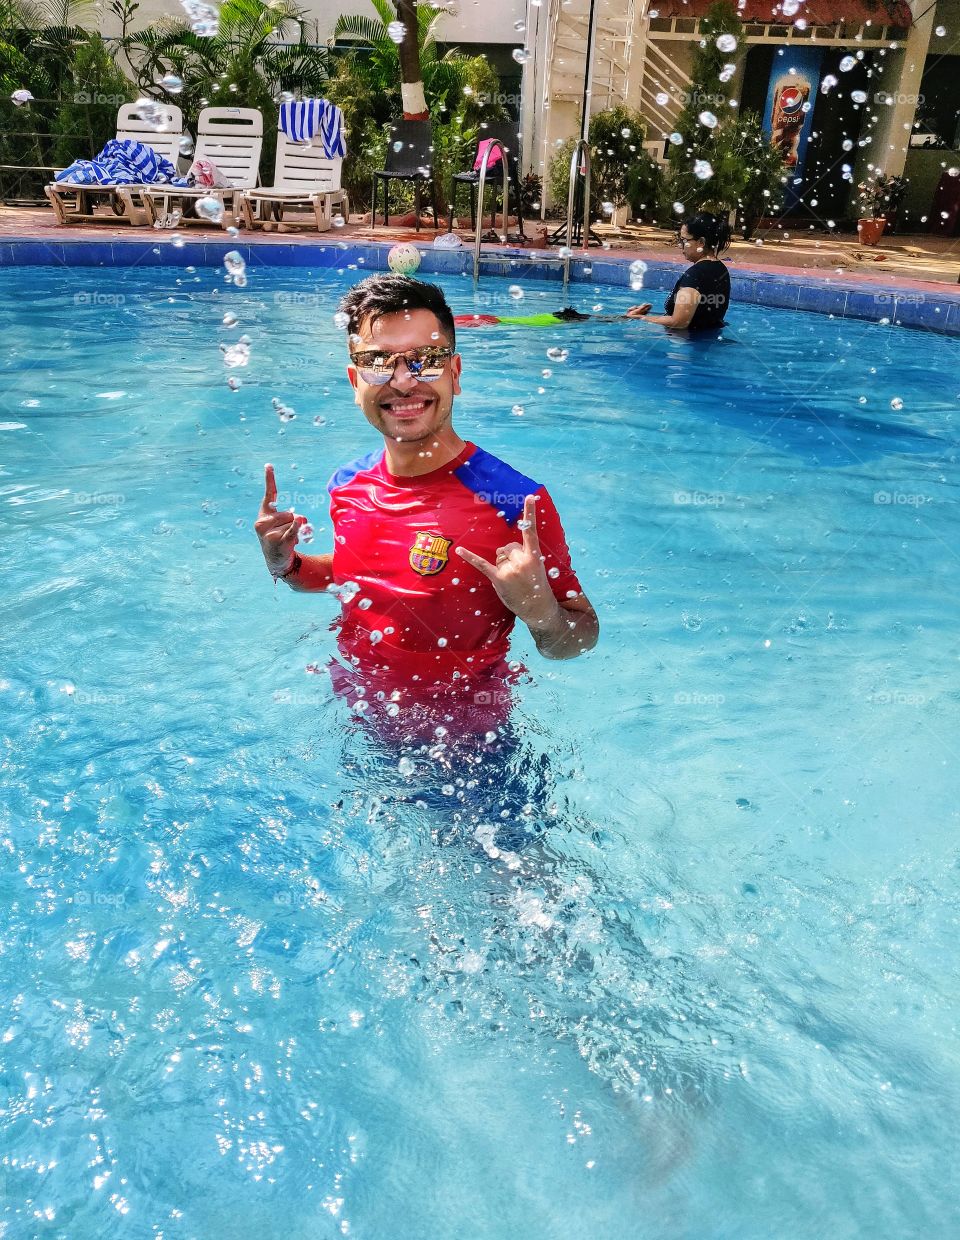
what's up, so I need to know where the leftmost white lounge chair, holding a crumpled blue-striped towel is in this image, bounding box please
[45,103,184,224]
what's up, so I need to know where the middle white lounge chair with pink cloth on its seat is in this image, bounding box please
[143,108,263,228]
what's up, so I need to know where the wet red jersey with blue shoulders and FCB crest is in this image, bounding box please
[327,443,582,682]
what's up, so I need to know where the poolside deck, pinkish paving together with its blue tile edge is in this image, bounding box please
[0,207,960,335]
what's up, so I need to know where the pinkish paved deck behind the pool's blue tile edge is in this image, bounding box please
[0,207,960,294]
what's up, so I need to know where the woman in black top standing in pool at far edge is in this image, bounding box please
[626,211,731,330]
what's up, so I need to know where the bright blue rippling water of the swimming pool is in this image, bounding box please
[0,259,960,1240]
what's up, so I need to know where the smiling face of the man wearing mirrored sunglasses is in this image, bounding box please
[347,310,460,444]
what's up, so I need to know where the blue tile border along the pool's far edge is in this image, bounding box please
[0,233,960,336]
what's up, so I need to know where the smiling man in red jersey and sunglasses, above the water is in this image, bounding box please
[254,275,599,724]
